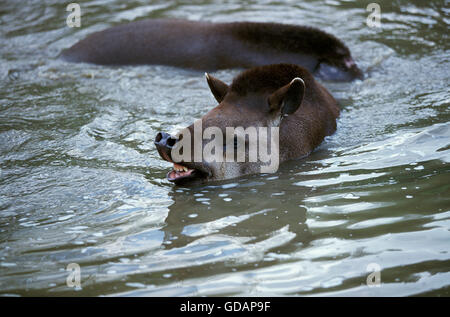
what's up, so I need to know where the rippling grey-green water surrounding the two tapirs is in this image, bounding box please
[0,0,450,296]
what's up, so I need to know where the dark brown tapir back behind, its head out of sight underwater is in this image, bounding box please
[61,19,363,81]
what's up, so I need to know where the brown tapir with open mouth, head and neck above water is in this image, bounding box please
[155,64,339,183]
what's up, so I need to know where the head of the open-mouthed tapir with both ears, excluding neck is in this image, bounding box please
[155,65,305,184]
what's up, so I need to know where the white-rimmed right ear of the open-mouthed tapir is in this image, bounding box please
[268,77,305,116]
